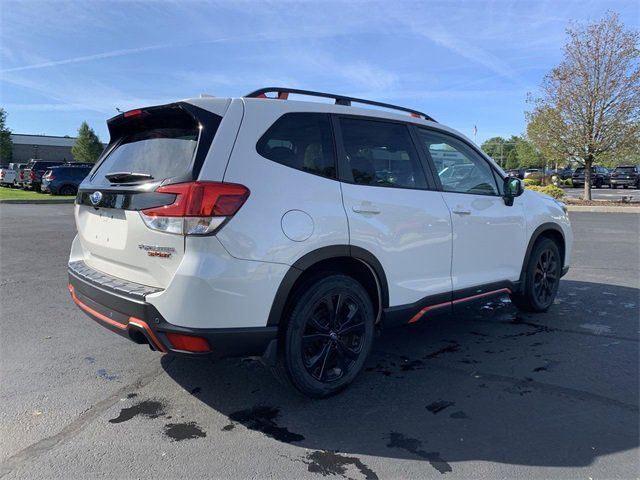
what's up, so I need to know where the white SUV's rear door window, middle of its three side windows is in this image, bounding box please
[340,118,427,188]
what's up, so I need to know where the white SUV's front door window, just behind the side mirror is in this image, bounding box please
[418,129,499,195]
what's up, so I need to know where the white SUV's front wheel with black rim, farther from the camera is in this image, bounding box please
[511,238,562,312]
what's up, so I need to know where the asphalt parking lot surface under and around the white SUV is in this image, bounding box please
[0,204,640,479]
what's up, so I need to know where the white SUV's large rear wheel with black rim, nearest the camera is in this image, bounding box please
[276,274,375,398]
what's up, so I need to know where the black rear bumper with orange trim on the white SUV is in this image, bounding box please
[68,262,278,358]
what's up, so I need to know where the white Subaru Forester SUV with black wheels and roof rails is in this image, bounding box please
[69,88,572,397]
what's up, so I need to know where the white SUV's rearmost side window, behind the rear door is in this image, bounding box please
[256,113,336,178]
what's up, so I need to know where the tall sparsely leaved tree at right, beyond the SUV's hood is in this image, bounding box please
[527,13,640,200]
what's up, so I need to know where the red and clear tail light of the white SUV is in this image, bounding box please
[140,182,250,235]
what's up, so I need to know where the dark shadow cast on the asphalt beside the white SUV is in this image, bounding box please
[162,281,640,473]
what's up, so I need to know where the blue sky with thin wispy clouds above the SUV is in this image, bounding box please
[0,0,640,143]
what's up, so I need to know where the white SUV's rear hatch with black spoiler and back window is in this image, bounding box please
[75,102,222,288]
